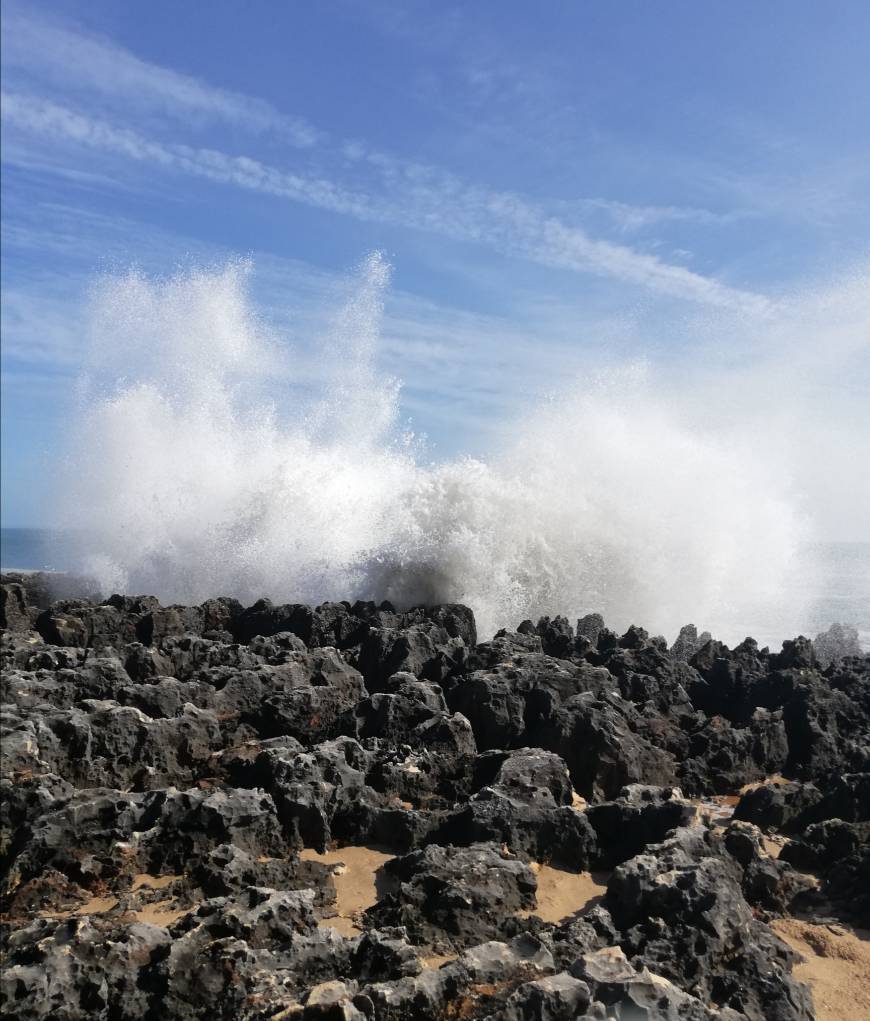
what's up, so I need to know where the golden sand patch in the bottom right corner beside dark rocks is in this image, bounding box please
[771,918,870,1021]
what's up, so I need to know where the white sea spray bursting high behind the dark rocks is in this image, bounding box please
[61,255,865,641]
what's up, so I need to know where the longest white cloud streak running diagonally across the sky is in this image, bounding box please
[3,92,767,312]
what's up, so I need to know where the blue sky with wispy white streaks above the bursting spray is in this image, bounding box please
[2,0,870,533]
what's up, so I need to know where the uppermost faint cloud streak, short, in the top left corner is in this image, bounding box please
[3,10,323,148]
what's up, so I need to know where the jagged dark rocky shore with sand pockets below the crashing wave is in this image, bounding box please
[0,575,870,1021]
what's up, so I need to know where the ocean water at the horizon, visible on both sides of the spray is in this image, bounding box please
[0,528,870,651]
